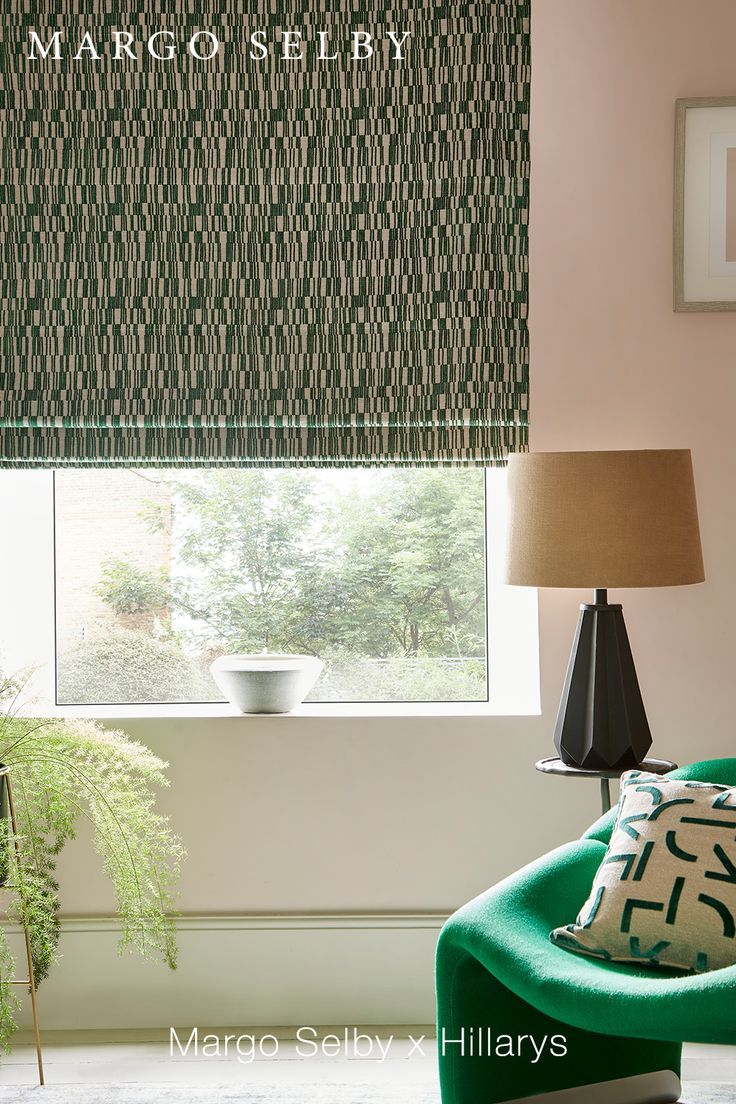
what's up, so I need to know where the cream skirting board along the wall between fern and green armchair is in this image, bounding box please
[5,913,446,1030]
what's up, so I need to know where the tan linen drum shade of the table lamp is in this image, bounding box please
[506,448,705,588]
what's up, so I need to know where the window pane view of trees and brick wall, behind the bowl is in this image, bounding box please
[55,468,487,704]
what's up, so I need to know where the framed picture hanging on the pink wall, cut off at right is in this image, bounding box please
[674,96,736,310]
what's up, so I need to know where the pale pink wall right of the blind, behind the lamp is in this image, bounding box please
[531,0,736,760]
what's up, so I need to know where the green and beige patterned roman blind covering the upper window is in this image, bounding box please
[0,0,530,466]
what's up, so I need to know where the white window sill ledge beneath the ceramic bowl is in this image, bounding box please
[24,701,541,722]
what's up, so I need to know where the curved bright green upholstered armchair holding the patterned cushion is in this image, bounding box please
[437,758,736,1104]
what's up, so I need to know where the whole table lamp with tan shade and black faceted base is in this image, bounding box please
[506,448,705,771]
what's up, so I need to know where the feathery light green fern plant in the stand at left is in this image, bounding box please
[0,679,184,1049]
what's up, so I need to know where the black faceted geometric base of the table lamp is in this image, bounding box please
[554,591,652,769]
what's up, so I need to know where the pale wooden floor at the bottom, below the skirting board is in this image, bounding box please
[0,1026,736,1100]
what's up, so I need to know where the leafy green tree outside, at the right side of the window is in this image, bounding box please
[326,470,486,657]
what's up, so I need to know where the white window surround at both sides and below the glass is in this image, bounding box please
[0,468,541,721]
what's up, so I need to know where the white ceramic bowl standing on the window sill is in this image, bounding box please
[210,651,324,713]
